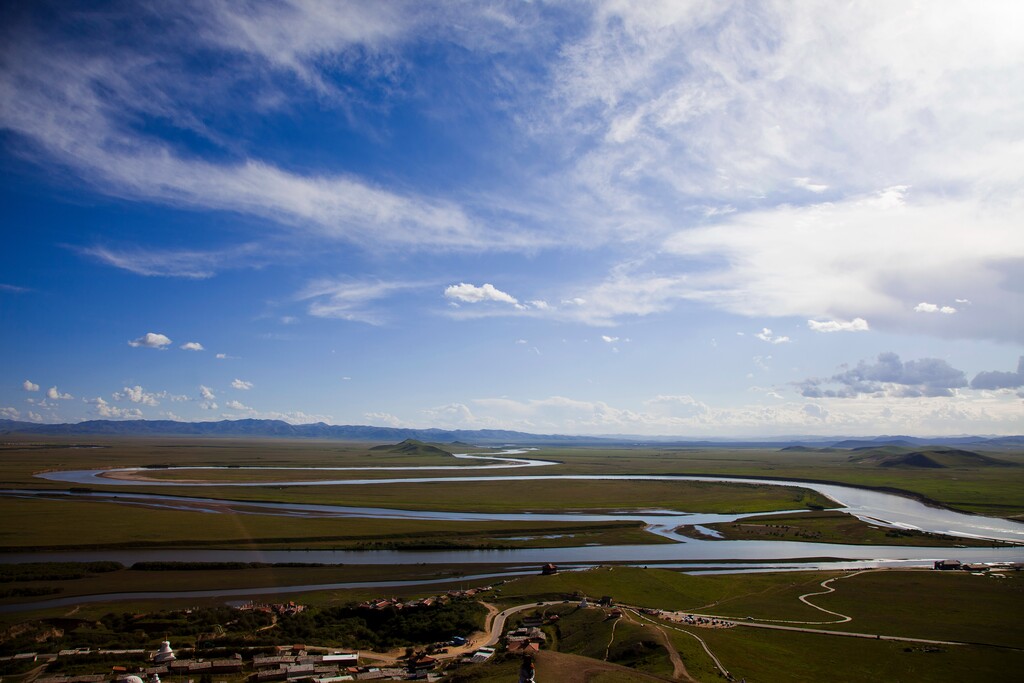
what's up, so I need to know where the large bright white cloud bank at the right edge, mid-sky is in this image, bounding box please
[651,188,1024,339]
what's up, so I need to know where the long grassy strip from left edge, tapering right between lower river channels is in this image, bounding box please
[0,499,669,551]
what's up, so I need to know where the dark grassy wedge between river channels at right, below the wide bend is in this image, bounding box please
[679,511,1013,548]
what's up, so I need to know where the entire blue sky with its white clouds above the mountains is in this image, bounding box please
[0,0,1024,436]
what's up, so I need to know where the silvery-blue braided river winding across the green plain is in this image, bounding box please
[8,450,1024,568]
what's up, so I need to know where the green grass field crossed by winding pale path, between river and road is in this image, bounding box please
[491,567,1024,647]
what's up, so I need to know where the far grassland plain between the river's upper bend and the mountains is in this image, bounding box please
[0,436,1024,518]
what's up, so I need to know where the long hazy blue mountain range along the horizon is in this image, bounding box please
[0,420,1024,449]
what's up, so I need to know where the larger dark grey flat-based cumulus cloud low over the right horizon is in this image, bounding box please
[798,352,968,398]
